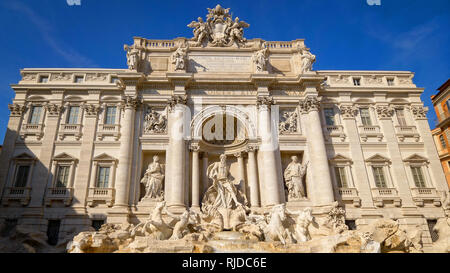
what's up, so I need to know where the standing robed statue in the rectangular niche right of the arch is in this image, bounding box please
[284,155,308,199]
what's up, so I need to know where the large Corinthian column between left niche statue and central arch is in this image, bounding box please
[166,95,187,208]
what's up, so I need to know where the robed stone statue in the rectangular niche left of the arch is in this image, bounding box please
[141,155,164,200]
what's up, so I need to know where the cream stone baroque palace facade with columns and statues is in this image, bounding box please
[0,6,449,252]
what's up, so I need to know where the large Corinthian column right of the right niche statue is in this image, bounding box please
[300,96,334,206]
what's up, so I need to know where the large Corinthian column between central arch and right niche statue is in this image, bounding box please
[258,97,284,206]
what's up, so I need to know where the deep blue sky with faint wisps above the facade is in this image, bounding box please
[0,0,450,140]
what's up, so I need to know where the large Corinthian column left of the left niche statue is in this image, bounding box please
[114,96,139,207]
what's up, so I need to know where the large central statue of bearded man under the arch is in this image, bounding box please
[202,154,247,214]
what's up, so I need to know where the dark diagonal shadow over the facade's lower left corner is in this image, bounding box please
[0,128,96,253]
